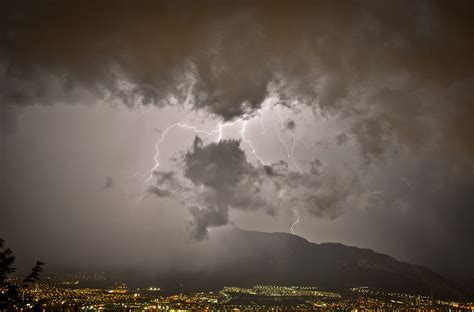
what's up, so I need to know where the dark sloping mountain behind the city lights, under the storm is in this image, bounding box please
[149,228,463,298]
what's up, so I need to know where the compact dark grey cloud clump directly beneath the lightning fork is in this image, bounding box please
[180,137,272,239]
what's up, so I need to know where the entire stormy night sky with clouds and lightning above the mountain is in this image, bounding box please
[0,0,474,279]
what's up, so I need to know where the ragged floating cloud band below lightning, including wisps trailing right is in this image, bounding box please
[149,137,374,240]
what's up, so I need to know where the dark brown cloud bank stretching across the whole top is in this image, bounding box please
[0,1,474,145]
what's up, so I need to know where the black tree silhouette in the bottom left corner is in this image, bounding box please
[0,238,44,310]
